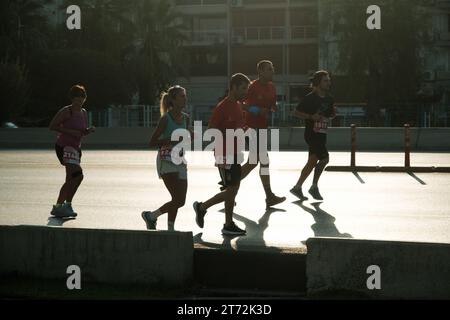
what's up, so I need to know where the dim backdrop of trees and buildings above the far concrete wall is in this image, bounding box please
[0,0,450,128]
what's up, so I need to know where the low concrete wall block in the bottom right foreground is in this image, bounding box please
[306,238,450,299]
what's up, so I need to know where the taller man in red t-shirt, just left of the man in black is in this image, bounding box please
[242,60,286,207]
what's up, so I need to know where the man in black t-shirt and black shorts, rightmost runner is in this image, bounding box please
[291,70,336,200]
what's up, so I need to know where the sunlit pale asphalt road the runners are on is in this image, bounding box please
[0,150,450,250]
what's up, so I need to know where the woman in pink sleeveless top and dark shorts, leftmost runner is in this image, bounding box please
[50,85,95,218]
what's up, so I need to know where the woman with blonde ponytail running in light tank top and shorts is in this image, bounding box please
[141,86,189,231]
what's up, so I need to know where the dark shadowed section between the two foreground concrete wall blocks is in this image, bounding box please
[194,249,306,295]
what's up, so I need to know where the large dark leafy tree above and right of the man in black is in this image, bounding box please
[322,0,429,124]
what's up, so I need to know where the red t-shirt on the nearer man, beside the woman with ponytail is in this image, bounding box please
[209,97,245,162]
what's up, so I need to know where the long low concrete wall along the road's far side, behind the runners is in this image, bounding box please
[0,128,450,151]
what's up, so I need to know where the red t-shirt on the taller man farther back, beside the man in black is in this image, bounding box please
[245,80,277,129]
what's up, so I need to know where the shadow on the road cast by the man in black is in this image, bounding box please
[293,200,353,238]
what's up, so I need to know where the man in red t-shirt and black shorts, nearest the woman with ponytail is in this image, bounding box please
[194,73,250,235]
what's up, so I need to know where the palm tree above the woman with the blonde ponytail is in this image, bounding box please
[124,0,185,104]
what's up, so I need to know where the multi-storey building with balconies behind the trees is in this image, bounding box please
[42,0,450,126]
